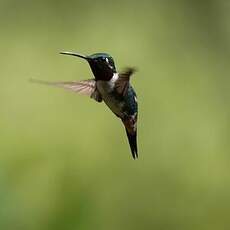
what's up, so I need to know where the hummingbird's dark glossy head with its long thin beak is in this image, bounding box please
[60,52,116,80]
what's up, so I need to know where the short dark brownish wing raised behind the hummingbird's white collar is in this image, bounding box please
[115,67,136,96]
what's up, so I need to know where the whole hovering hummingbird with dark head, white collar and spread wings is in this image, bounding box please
[32,52,138,159]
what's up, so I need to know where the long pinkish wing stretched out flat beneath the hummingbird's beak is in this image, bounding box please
[31,79,96,96]
